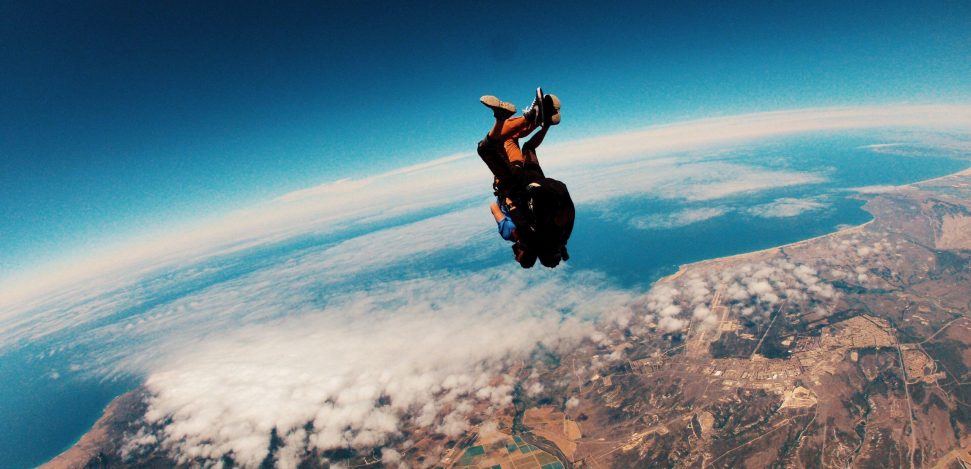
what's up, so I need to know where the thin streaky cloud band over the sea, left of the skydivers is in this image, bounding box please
[0,207,494,350]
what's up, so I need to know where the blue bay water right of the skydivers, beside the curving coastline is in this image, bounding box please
[570,137,971,288]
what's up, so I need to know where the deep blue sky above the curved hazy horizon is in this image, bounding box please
[0,0,971,279]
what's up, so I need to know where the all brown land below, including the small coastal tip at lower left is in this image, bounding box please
[51,167,971,469]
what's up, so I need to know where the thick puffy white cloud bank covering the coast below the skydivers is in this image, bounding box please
[117,268,630,467]
